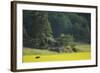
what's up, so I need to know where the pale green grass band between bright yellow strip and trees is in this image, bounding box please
[23,44,91,55]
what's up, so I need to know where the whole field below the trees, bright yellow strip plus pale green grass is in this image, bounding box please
[23,44,91,62]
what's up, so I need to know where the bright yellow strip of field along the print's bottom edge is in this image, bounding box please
[23,52,91,62]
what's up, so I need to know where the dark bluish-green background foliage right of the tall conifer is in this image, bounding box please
[49,12,91,43]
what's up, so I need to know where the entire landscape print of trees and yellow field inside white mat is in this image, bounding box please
[23,10,91,62]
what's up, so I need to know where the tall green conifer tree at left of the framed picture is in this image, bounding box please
[27,11,52,48]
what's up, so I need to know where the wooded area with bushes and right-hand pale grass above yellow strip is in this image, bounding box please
[23,10,91,53]
